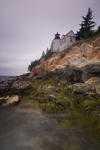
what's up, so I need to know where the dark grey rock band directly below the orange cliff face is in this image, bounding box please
[45,63,100,83]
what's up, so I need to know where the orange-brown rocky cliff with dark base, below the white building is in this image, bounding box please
[29,36,100,82]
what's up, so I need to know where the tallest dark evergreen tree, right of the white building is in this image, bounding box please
[76,8,96,39]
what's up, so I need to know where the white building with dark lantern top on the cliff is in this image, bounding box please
[51,30,76,52]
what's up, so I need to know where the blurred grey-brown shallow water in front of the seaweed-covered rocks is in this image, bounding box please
[0,107,100,150]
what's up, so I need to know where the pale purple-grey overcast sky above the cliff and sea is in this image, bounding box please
[0,0,100,75]
